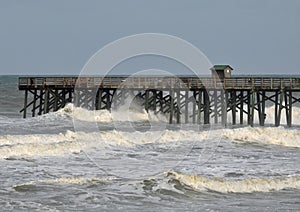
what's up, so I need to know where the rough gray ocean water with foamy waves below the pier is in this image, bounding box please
[0,76,300,211]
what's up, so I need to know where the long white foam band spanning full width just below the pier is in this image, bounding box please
[0,127,300,158]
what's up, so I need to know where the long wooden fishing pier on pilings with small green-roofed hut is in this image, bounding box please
[19,65,300,127]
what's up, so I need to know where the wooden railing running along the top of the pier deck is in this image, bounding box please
[19,76,300,90]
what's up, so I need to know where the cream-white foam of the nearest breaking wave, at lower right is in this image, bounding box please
[166,172,300,193]
